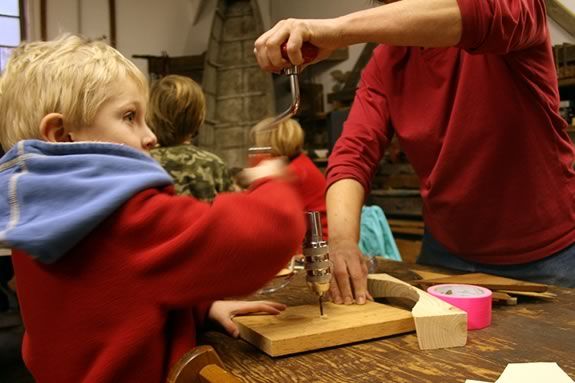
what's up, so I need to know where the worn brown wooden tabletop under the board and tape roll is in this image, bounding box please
[200,261,575,383]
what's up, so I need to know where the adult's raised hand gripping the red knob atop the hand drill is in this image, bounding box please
[254,19,344,72]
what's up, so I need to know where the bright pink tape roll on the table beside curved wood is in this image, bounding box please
[427,284,492,330]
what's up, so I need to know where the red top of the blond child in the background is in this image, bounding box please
[289,153,328,240]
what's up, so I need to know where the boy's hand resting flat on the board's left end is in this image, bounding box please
[208,301,287,338]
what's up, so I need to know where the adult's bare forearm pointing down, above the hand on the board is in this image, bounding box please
[326,179,365,243]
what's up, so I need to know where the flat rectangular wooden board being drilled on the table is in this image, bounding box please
[234,302,415,356]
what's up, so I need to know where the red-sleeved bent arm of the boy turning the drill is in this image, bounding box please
[113,179,305,307]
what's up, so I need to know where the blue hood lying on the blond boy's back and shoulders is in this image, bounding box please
[0,140,172,263]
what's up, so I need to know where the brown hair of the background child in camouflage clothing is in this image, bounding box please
[147,75,206,146]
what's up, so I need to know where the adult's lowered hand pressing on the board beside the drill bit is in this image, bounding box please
[329,240,372,305]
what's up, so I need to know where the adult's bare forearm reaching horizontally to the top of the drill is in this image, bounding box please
[336,0,462,47]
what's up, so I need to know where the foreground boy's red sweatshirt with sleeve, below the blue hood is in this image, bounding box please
[13,181,304,383]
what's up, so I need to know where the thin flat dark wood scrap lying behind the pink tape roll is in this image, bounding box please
[412,273,548,293]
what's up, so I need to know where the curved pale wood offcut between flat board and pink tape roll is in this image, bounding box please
[367,274,467,350]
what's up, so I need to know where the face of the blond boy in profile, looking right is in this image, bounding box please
[70,78,157,151]
